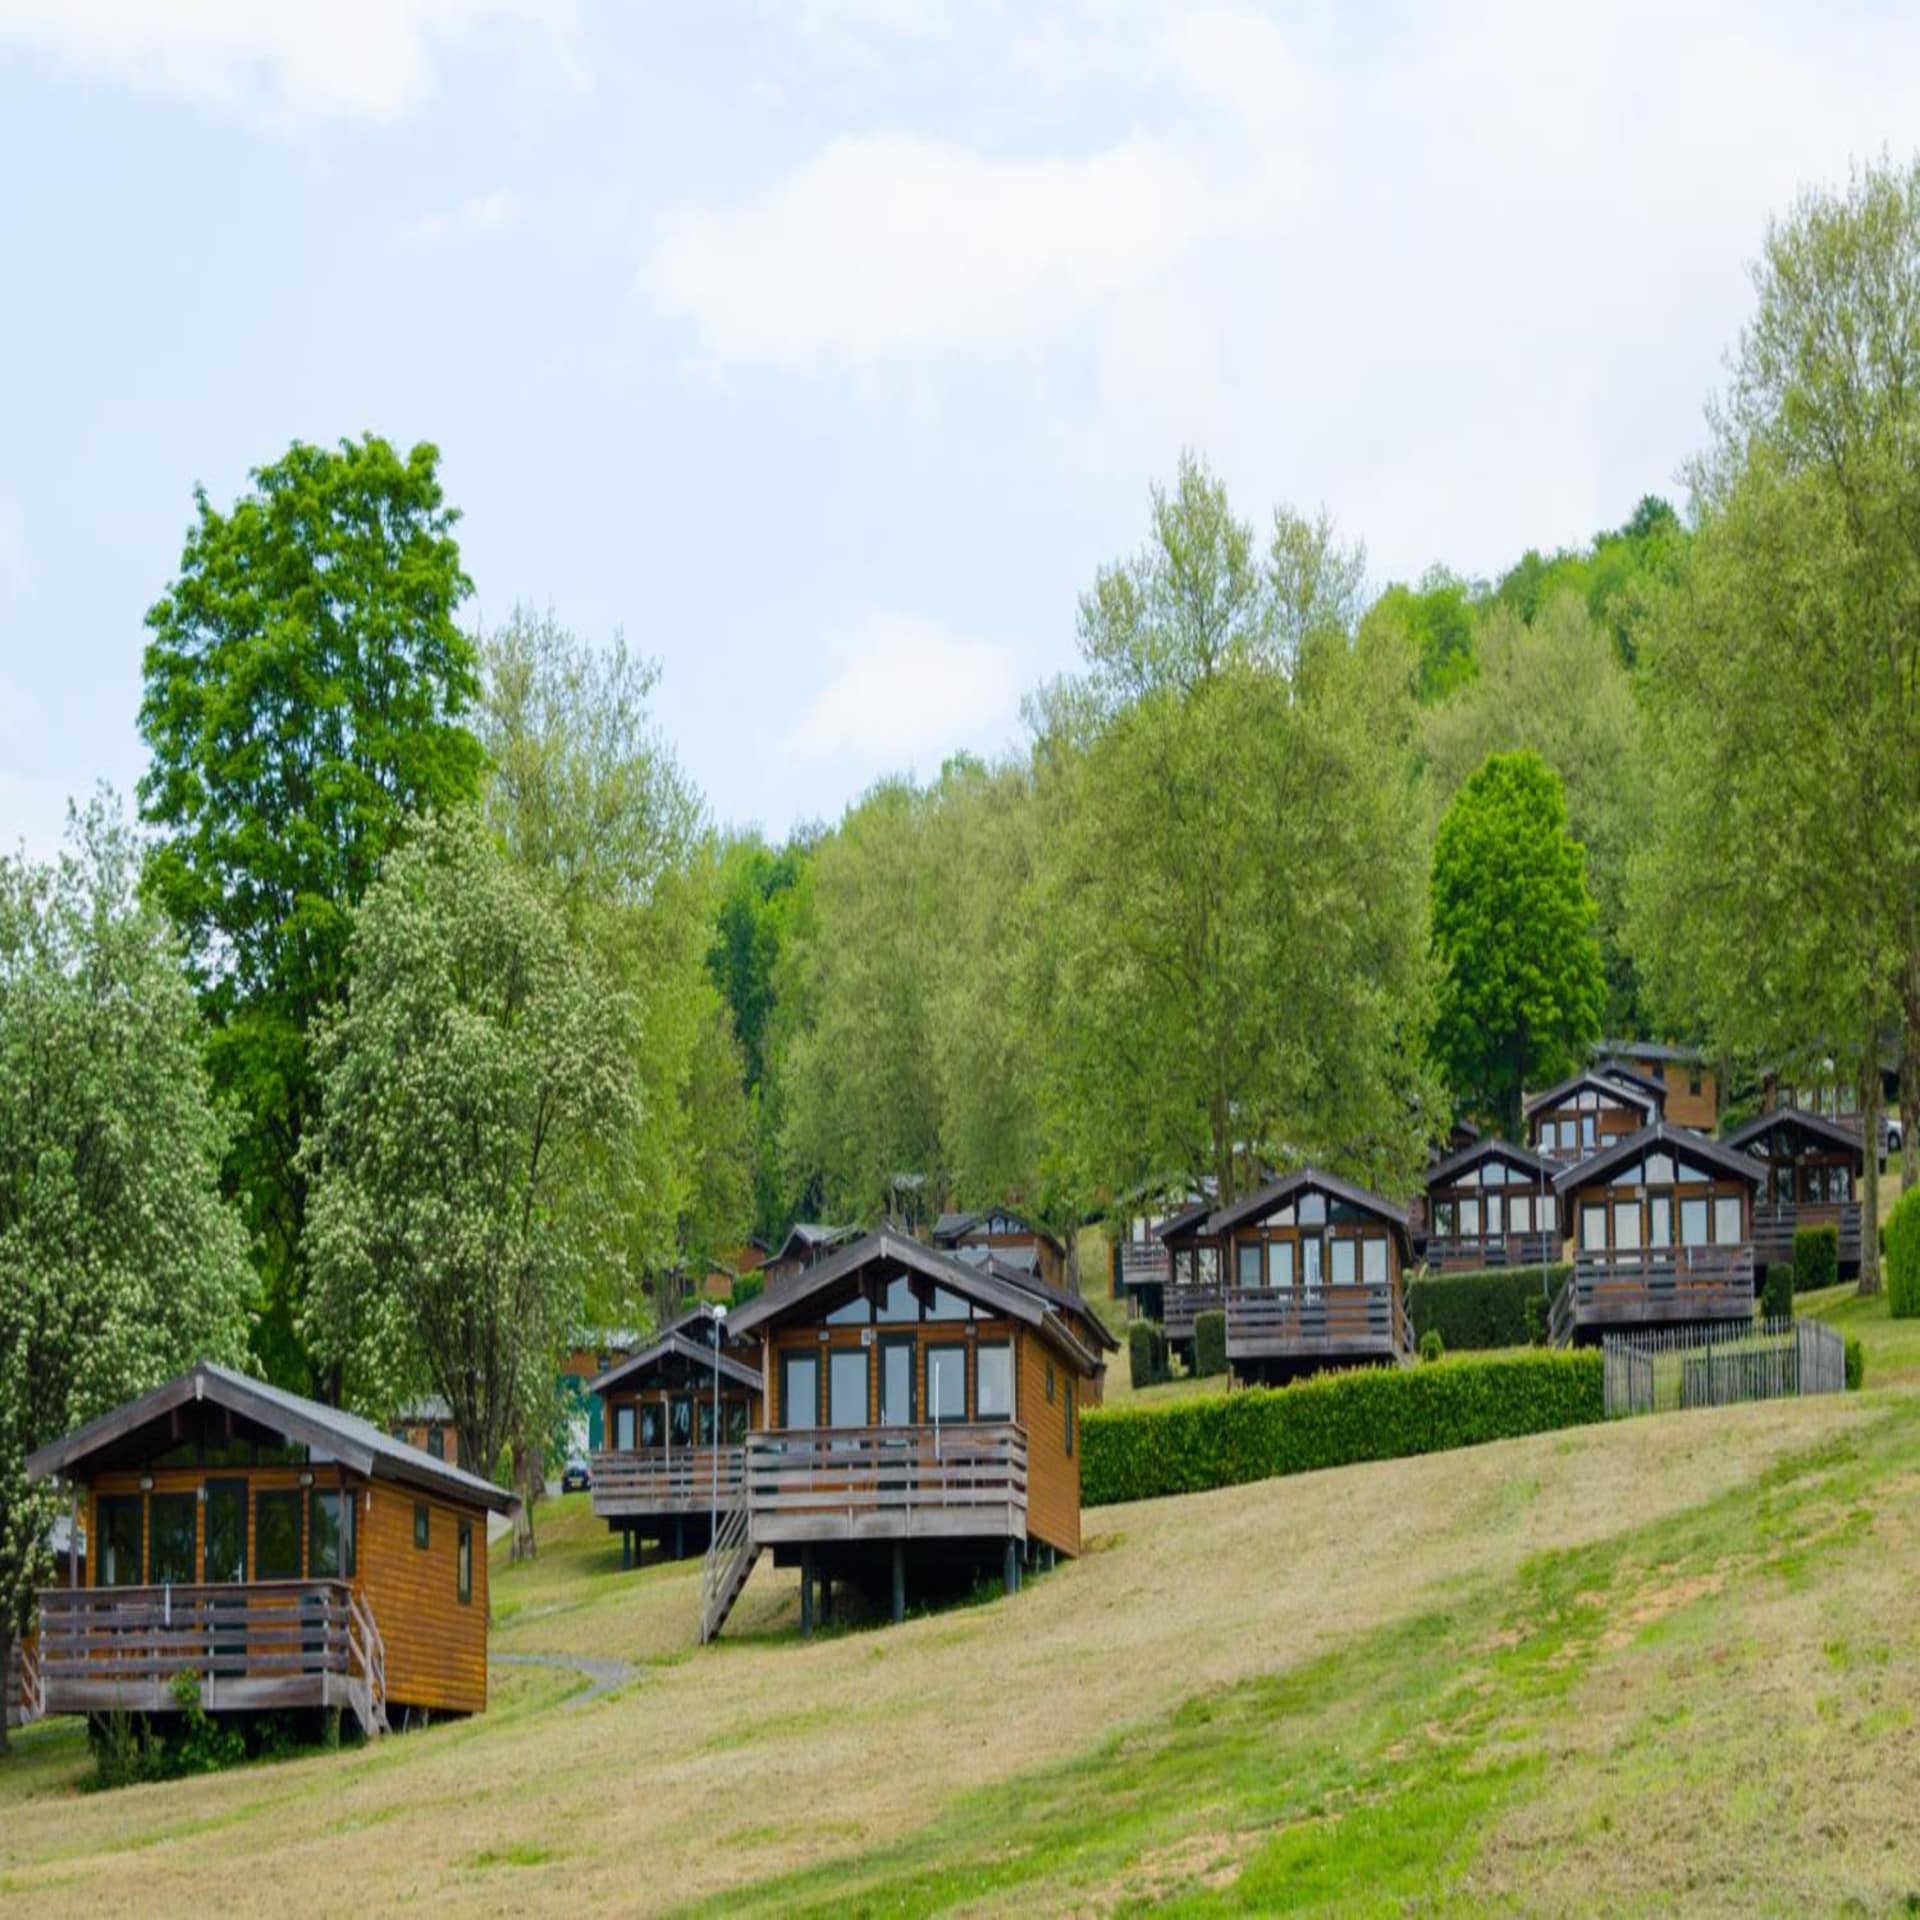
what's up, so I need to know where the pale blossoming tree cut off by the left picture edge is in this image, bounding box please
[0,801,252,1747]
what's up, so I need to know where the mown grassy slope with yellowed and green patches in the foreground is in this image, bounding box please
[11,1302,1920,1912]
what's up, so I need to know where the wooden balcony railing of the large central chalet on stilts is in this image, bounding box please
[747,1421,1027,1546]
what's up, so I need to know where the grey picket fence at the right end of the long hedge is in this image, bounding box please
[1599,1319,1847,1419]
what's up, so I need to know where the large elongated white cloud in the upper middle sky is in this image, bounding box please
[643,132,1206,365]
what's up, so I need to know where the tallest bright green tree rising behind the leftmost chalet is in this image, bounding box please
[140,436,480,1396]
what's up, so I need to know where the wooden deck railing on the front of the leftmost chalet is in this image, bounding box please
[38,1580,386,1734]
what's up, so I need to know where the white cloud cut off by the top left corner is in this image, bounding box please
[0,0,574,125]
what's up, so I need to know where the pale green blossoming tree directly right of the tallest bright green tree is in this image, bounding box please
[301,808,636,1546]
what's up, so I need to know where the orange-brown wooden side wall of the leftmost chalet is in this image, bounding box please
[359,1482,488,1713]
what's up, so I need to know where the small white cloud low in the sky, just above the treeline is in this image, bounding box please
[783,612,1021,771]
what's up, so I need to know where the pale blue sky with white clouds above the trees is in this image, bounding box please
[0,0,1920,852]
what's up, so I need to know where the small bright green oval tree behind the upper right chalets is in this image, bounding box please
[1432,753,1607,1140]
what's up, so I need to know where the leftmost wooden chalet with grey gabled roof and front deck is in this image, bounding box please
[27,1361,516,1734]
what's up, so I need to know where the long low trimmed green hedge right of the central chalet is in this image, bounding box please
[1081,1348,1601,1507]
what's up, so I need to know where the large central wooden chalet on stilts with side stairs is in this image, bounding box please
[701,1229,1100,1640]
